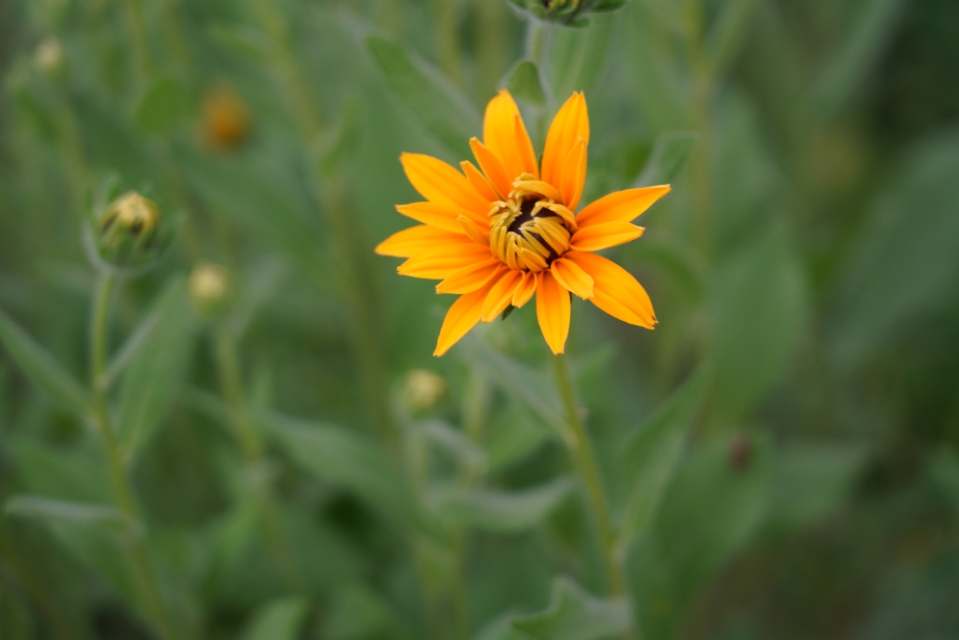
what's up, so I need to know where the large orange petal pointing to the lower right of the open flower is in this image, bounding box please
[563,251,656,329]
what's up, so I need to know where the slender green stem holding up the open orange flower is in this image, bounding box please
[553,355,626,598]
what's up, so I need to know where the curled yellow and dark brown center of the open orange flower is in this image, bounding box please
[489,175,576,271]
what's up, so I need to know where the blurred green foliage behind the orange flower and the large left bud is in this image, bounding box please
[0,0,959,640]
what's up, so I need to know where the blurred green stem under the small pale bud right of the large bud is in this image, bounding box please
[214,326,305,591]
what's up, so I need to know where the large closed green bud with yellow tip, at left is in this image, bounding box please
[88,183,175,270]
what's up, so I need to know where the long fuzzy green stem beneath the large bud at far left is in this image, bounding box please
[90,270,182,640]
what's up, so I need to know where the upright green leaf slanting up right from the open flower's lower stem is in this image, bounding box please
[618,369,711,546]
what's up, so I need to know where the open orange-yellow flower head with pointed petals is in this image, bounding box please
[376,91,669,356]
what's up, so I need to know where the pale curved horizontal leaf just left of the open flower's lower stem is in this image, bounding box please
[436,478,573,533]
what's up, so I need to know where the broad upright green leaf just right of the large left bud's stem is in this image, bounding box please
[119,278,197,456]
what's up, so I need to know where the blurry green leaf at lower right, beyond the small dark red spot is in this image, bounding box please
[770,443,868,529]
